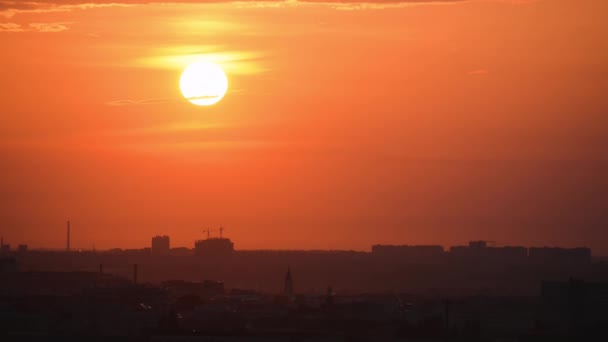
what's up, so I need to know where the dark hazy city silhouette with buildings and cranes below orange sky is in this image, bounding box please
[0,223,608,341]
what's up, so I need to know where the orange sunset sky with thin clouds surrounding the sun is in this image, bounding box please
[0,0,608,255]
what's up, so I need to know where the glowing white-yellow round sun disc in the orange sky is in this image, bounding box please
[179,61,228,106]
